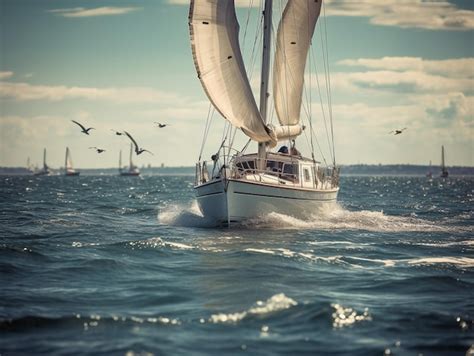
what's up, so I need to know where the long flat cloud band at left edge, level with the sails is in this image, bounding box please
[0,81,177,103]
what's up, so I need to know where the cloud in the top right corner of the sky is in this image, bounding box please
[325,0,474,31]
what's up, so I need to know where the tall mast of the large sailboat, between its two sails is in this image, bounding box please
[258,0,273,170]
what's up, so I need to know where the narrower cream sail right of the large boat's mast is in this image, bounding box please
[273,0,322,138]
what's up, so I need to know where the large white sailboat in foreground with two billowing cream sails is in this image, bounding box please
[189,0,339,225]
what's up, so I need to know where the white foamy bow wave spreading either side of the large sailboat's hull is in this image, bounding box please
[158,201,467,232]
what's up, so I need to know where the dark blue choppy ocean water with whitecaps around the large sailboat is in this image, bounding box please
[0,175,474,356]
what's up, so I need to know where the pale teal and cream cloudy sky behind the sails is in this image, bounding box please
[0,0,474,168]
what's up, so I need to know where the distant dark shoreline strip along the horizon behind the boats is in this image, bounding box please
[0,164,474,177]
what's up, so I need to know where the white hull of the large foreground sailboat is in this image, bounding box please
[194,179,339,224]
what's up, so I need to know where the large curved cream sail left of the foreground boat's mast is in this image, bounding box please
[189,0,276,144]
